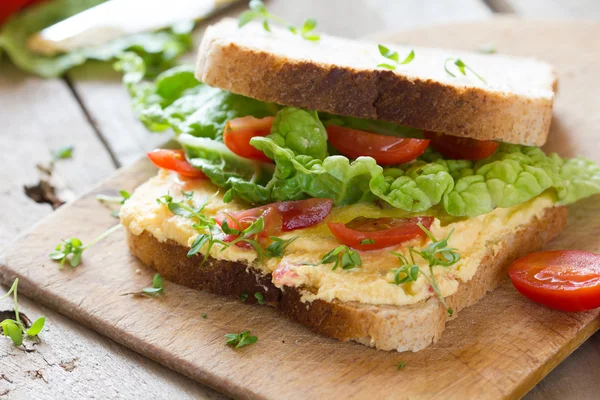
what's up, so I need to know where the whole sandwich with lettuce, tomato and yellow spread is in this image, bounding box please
[120,17,600,351]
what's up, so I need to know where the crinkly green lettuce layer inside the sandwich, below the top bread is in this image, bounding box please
[123,59,600,217]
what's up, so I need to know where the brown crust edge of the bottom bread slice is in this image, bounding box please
[127,207,567,351]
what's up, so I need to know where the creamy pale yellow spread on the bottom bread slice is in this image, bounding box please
[120,171,554,305]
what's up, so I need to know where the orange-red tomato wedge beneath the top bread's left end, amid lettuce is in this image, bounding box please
[223,116,275,162]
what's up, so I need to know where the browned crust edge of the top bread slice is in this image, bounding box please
[196,21,556,146]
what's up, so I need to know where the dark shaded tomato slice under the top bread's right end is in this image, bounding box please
[425,132,498,160]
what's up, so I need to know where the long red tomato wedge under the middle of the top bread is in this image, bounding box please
[327,125,429,165]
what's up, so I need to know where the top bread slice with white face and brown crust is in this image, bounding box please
[196,19,556,146]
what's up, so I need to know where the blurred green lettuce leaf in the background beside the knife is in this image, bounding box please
[0,0,193,77]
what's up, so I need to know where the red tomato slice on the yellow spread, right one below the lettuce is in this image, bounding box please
[327,217,433,250]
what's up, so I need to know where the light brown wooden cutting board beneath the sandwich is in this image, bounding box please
[0,19,600,399]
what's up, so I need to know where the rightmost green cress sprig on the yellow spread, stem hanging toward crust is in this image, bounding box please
[391,222,460,316]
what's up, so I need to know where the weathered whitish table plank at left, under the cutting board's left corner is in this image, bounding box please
[0,61,219,399]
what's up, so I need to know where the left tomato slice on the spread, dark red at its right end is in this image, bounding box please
[216,199,333,246]
